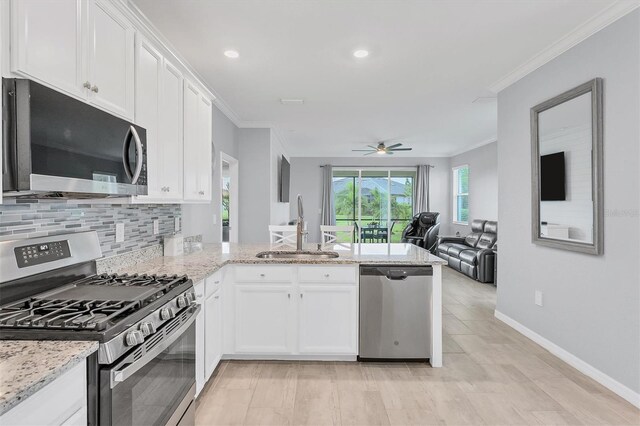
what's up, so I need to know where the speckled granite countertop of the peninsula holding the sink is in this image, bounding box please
[114,243,446,282]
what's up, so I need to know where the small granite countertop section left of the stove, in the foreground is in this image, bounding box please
[0,340,98,415]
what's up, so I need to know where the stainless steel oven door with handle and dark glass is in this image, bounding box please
[98,306,200,425]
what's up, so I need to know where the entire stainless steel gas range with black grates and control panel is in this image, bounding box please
[0,232,200,425]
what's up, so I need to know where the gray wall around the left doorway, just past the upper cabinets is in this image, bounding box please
[182,105,238,243]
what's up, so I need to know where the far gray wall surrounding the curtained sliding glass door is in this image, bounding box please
[290,157,451,242]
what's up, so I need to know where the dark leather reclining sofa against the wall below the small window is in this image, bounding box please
[436,219,498,283]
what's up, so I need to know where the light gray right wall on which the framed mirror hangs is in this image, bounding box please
[497,10,640,393]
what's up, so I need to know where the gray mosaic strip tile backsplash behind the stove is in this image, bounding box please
[0,198,182,256]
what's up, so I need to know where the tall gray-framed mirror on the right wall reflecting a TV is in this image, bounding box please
[531,78,604,255]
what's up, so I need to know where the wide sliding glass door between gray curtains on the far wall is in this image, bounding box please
[333,168,415,243]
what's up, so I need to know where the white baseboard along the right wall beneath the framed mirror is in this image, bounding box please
[494,310,640,408]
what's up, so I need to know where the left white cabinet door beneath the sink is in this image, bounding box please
[235,283,294,354]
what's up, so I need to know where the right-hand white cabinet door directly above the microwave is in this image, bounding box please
[87,0,135,119]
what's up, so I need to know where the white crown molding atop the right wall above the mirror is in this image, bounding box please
[489,0,640,93]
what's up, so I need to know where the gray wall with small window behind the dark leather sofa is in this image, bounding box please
[450,142,498,235]
